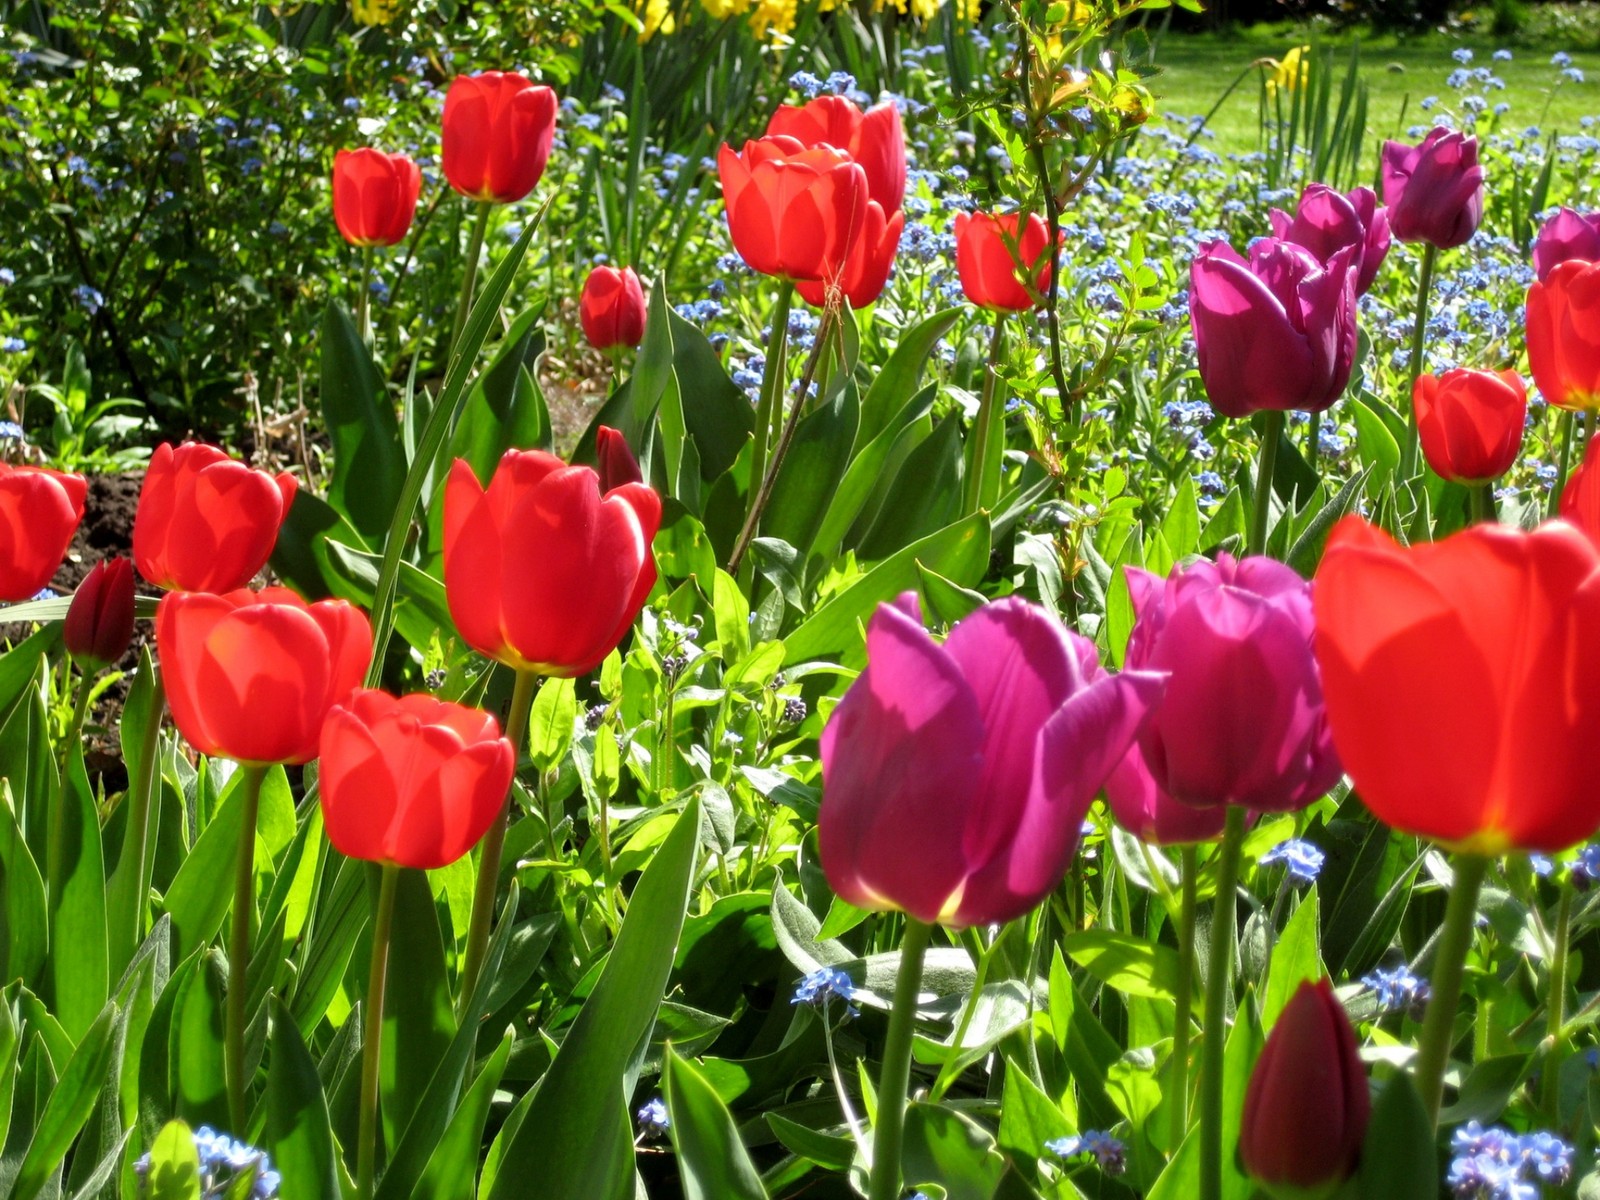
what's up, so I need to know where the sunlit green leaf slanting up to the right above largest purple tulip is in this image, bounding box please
[784,512,989,664]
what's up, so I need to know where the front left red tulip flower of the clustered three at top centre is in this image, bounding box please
[717,136,867,282]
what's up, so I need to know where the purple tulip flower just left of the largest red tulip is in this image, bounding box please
[1126,554,1342,813]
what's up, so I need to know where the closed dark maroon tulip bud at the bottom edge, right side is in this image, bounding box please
[1238,979,1371,1200]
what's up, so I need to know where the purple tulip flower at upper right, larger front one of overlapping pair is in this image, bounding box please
[1189,237,1357,418]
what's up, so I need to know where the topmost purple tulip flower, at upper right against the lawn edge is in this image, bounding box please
[1382,128,1483,250]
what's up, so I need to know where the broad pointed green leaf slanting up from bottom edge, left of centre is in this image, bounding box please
[488,797,701,1200]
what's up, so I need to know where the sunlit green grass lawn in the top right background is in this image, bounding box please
[1150,26,1600,154]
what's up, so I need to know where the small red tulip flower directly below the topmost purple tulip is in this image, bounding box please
[1411,370,1528,483]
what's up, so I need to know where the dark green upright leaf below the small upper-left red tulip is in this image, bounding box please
[320,301,405,546]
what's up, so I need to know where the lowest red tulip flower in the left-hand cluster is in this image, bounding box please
[317,688,517,870]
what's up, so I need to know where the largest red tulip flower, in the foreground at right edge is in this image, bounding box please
[1312,517,1600,856]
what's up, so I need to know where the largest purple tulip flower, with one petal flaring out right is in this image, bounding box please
[818,594,1162,926]
